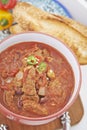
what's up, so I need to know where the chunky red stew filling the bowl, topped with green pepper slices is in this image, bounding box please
[0,42,75,117]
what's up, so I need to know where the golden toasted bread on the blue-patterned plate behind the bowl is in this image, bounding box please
[10,2,87,64]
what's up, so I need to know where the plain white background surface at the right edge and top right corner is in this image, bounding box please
[58,0,87,130]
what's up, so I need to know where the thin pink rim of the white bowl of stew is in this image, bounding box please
[0,31,82,121]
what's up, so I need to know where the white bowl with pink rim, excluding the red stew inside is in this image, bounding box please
[0,32,81,125]
